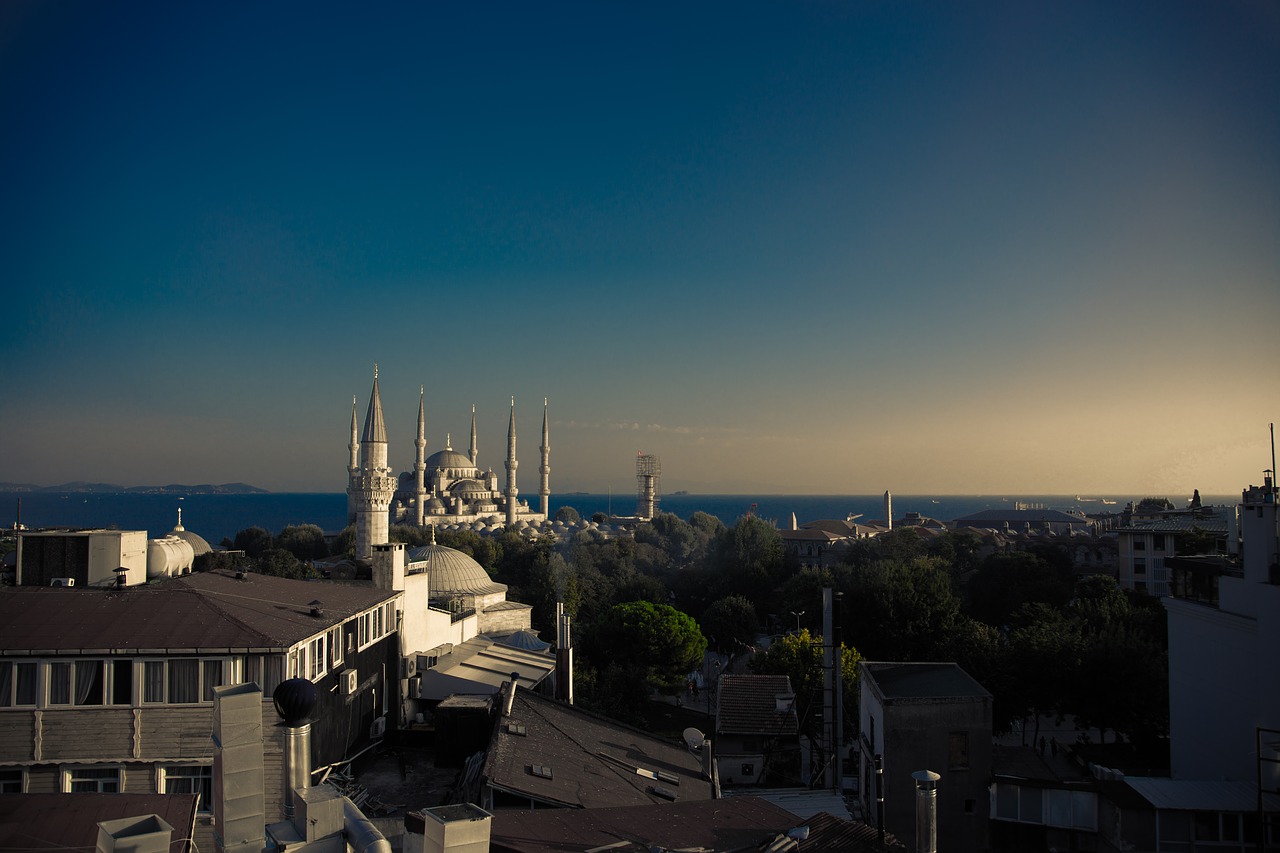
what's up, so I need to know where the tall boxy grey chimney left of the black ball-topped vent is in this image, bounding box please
[211,684,266,853]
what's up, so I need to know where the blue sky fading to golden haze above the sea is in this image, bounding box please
[0,0,1280,496]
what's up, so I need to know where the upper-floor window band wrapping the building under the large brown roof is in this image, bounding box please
[0,602,396,707]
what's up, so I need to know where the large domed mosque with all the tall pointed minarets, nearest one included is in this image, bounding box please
[347,365,550,560]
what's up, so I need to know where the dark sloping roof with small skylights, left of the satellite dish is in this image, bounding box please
[484,689,712,808]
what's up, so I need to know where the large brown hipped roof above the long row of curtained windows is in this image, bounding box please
[0,563,398,654]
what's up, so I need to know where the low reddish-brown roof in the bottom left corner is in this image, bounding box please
[0,794,196,850]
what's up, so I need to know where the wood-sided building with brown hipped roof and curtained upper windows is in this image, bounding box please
[0,571,401,850]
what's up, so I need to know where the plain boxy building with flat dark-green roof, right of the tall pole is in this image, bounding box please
[858,661,992,853]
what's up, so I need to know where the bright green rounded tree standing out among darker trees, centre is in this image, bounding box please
[589,601,707,690]
